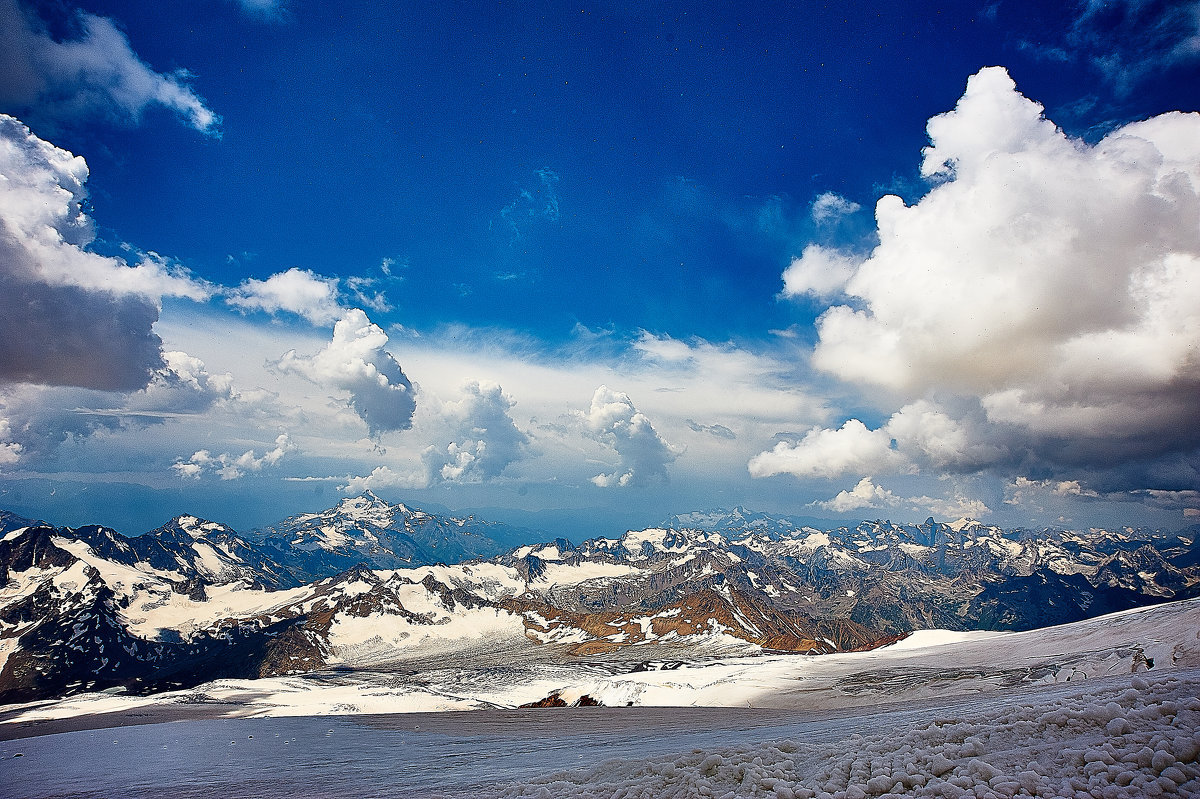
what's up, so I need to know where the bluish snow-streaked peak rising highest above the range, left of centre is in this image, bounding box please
[250,491,535,579]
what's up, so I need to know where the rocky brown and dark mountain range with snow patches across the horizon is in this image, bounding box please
[0,493,1200,703]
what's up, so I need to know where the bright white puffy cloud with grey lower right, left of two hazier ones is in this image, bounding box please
[277,308,416,435]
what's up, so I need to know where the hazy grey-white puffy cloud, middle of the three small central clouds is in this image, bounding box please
[422,382,529,483]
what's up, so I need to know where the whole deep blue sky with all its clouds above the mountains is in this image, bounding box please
[0,0,1200,539]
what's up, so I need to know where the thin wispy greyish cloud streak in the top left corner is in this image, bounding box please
[0,0,221,134]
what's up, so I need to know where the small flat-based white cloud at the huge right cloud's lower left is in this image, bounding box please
[749,419,907,477]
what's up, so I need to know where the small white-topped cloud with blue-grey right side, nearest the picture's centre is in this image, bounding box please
[577,385,680,488]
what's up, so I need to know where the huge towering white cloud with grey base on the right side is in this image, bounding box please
[751,67,1200,503]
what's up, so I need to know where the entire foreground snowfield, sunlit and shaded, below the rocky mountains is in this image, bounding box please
[0,600,1200,799]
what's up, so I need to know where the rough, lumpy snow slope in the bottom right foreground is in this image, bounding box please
[484,672,1200,799]
